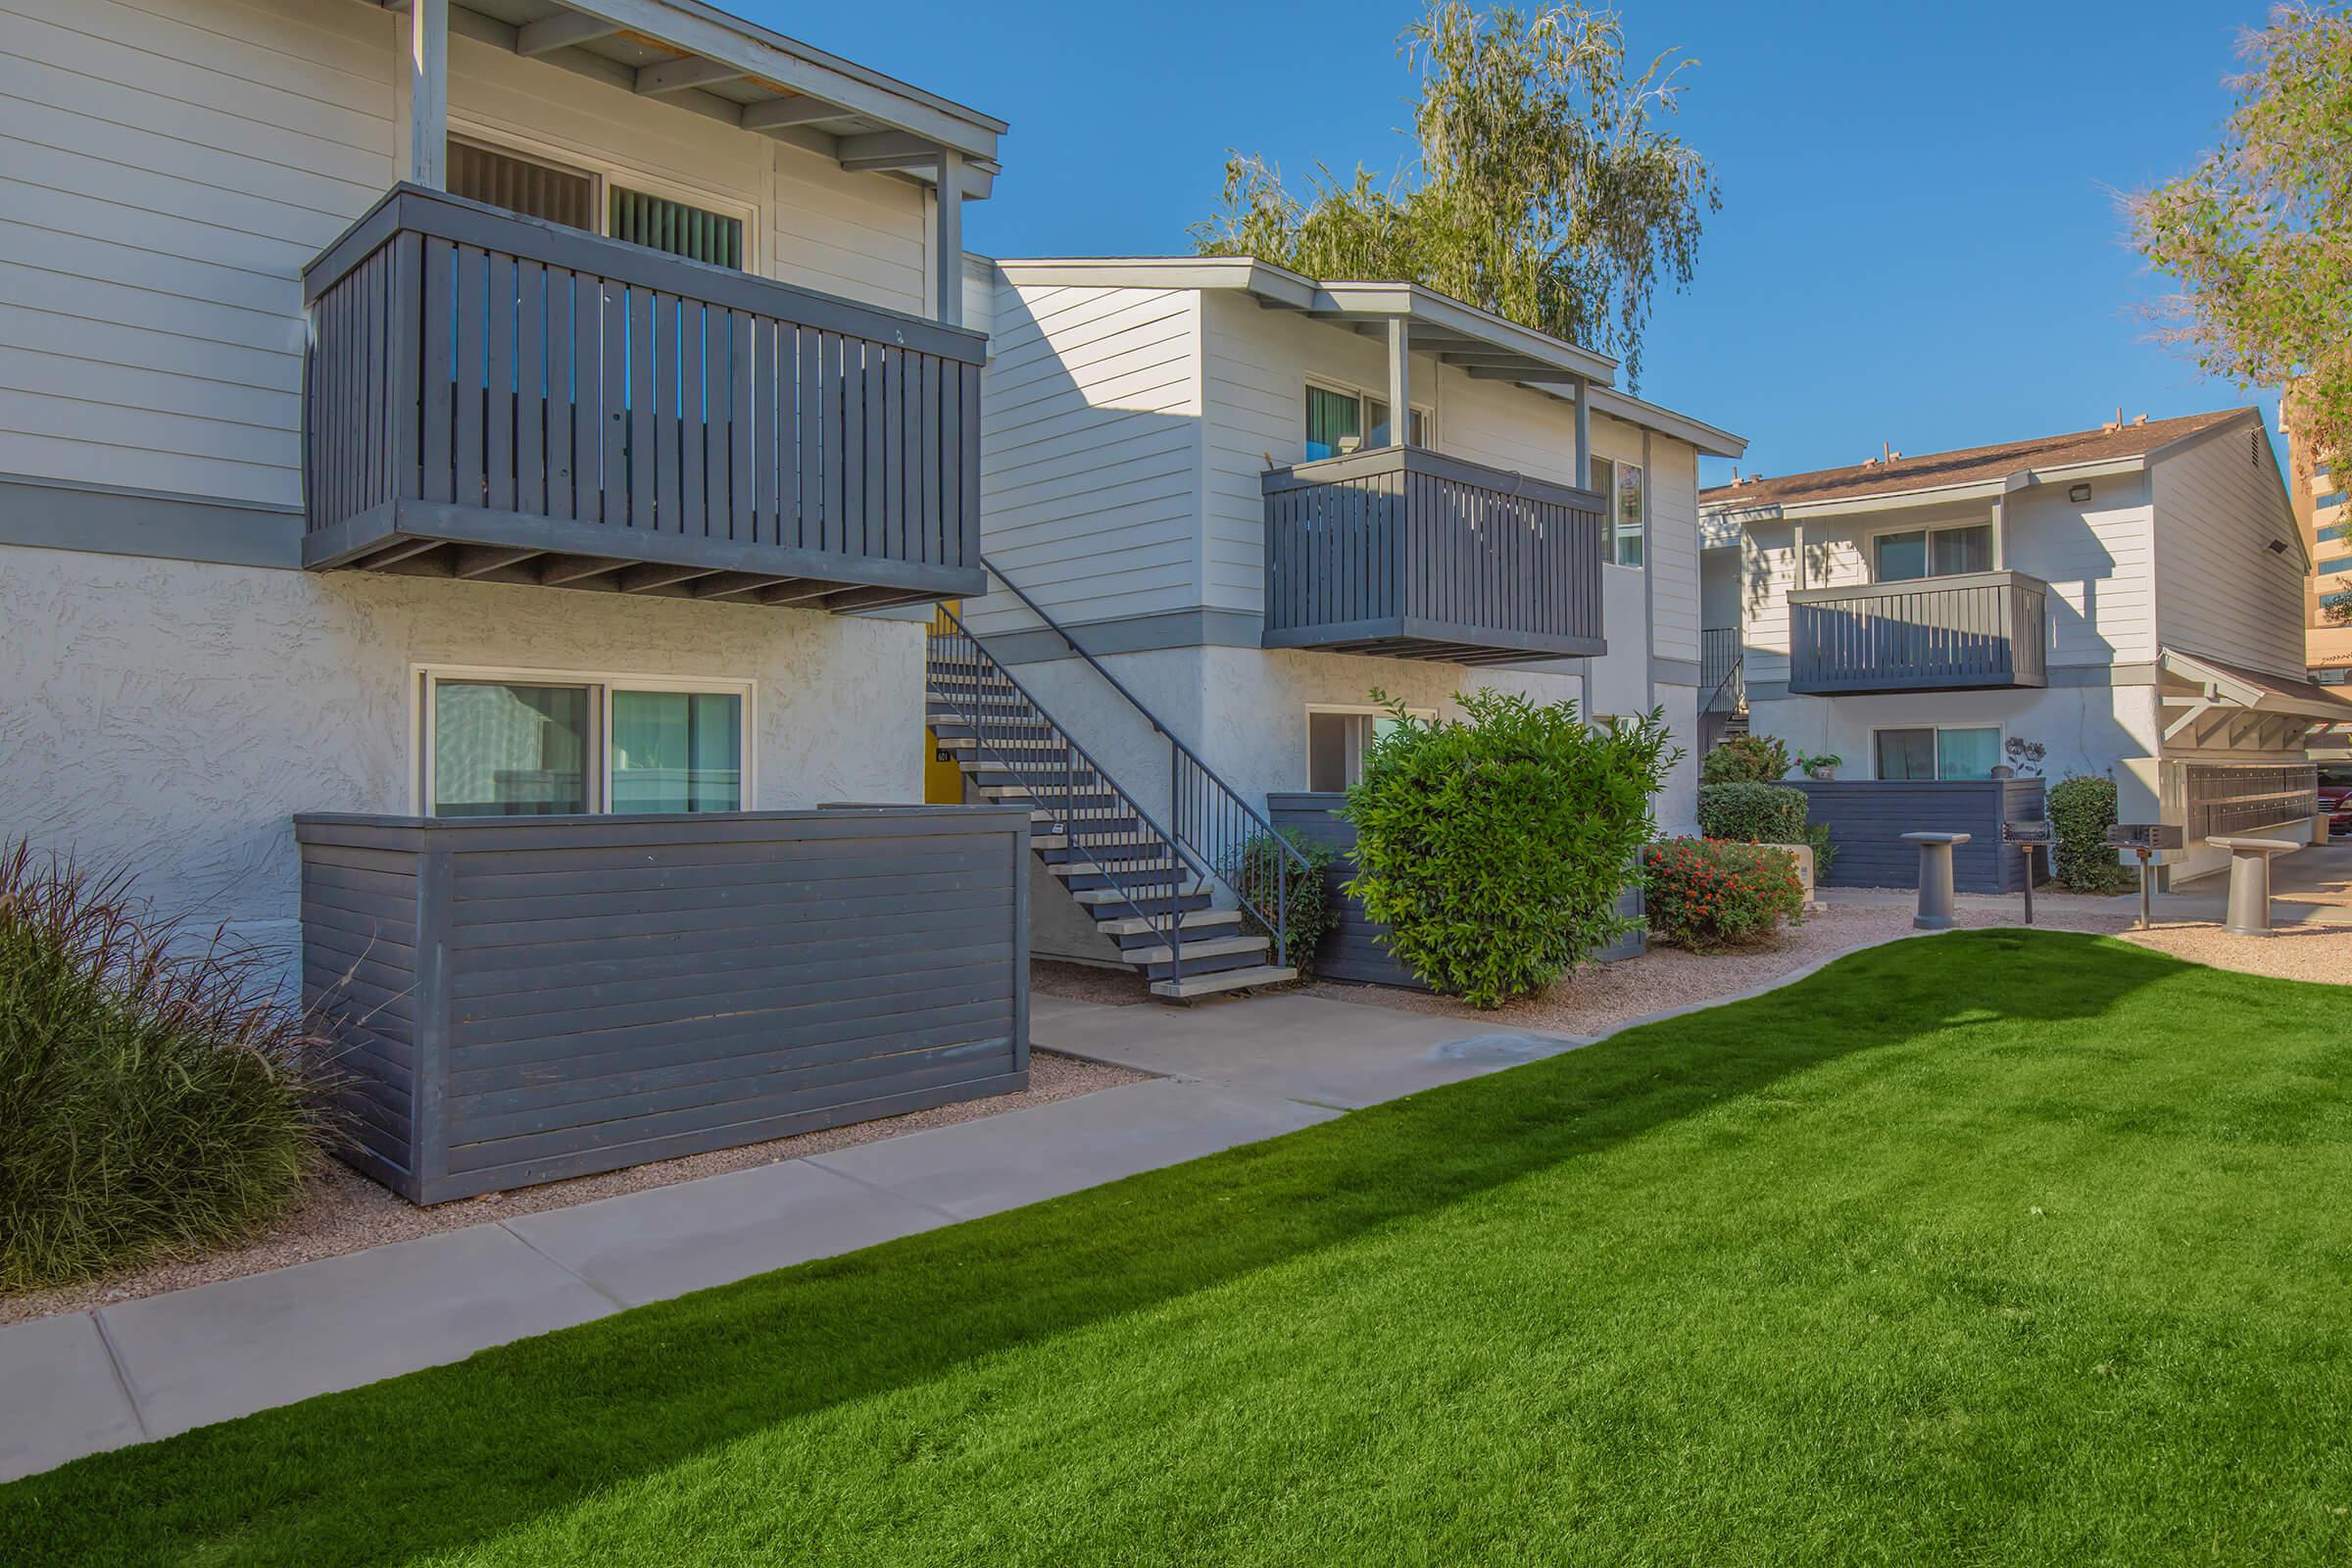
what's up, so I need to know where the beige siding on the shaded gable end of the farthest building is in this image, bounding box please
[2150,425,2305,679]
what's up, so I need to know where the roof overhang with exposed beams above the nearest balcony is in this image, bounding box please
[395,0,1006,197]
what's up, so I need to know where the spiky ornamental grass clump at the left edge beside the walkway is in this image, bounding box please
[0,842,322,1291]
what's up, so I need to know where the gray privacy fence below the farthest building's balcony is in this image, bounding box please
[1789,778,2051,894]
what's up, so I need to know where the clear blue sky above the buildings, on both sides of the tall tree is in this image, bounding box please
[743,0,2277,482]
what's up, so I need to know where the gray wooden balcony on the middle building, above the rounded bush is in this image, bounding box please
[1263,447,1609,662]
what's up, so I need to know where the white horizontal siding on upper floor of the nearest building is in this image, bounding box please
[0,0,929,506]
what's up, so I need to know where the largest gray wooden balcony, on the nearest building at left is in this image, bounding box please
[304,186,988,612]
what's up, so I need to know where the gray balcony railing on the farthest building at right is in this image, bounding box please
[1788,571,2048,696]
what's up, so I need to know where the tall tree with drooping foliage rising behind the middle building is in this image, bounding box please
[1193,0,1722,383]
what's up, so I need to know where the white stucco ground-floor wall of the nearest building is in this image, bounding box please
[0,546,922,982]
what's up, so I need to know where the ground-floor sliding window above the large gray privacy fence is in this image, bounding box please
[416,670,753,815]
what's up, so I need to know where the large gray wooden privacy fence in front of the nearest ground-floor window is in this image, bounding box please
[294,807,1028,1203]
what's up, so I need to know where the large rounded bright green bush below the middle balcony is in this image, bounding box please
[1343,691,1682,1008]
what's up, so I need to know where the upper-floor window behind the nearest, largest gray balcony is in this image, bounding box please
[449,136,751,270]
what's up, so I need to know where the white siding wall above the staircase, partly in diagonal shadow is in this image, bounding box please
[974,282,1200,632]
